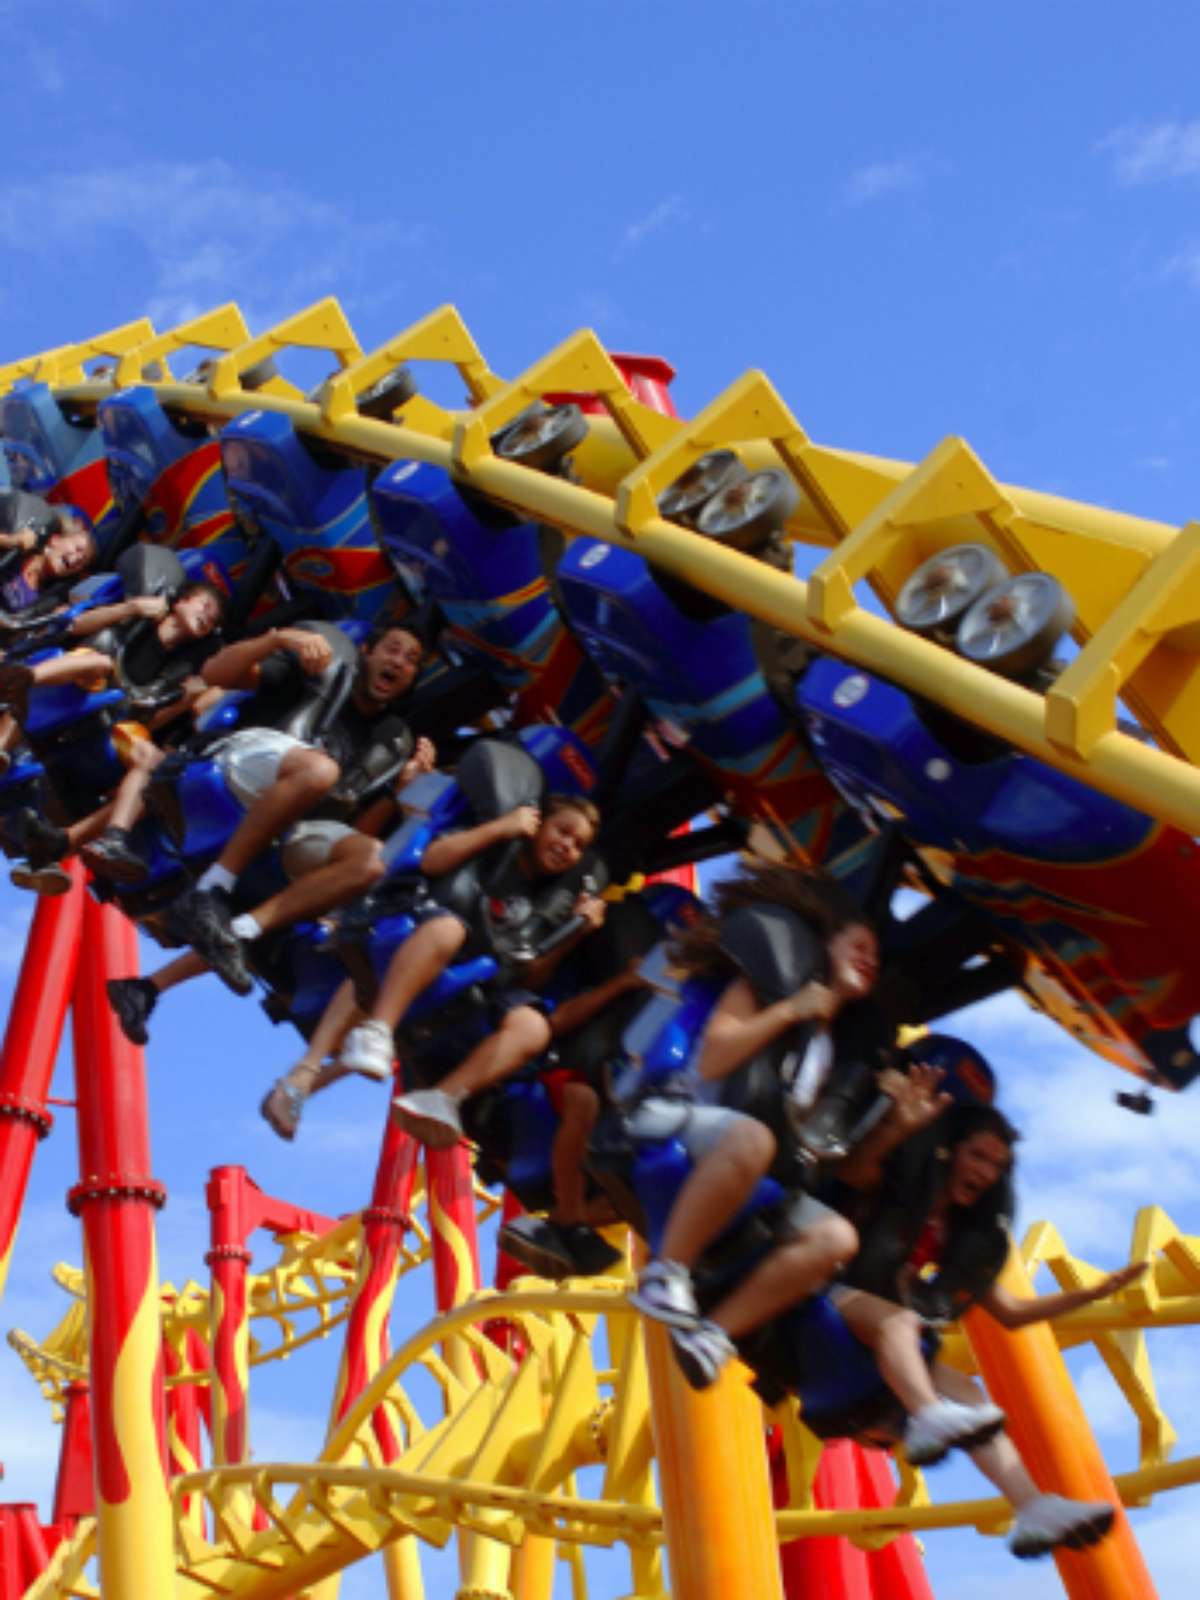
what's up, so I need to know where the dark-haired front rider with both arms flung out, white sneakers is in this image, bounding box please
[830,1067,1146,1557]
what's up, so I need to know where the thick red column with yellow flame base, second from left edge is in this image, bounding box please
[67,898,174,1600]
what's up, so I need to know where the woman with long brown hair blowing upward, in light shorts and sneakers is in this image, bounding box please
[626,866,878,1387]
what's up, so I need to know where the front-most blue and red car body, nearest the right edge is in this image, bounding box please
[797,658,1200,1088]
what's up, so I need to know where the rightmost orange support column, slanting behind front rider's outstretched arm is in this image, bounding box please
[963,1251,1157,1600]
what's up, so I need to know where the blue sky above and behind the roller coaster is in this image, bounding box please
[0,0,1200,1600]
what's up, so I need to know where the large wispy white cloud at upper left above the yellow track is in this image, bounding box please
[0,160,426,334]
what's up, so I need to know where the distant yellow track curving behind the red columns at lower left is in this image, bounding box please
[8,1187,499,1421]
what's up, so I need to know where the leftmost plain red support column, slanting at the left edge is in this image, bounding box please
[0,867,83,1296]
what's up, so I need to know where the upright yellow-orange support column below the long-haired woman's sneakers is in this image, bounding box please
[645,1323,784,1600]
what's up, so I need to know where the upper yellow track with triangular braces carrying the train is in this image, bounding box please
[0,299,1200,834]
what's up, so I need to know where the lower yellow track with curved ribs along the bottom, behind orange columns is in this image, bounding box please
[16,1206,1200,1600]
